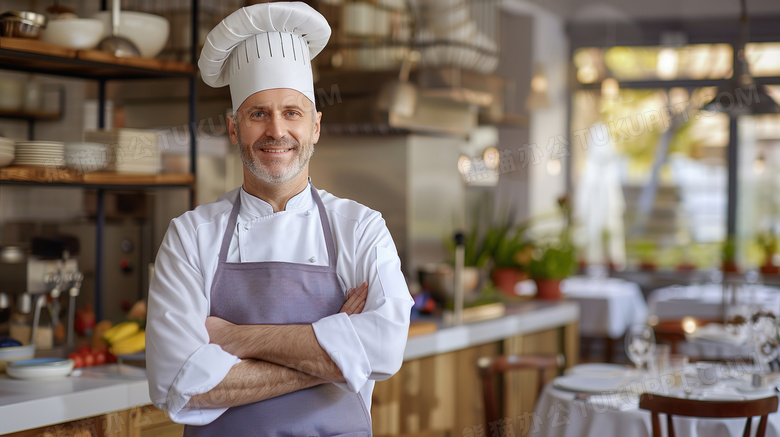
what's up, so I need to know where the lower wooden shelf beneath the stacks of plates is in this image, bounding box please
[0,165,195,187]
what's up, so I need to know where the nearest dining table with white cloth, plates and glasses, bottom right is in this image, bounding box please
[524,362,780,437]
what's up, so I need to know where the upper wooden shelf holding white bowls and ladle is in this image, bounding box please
[0,37,195,79]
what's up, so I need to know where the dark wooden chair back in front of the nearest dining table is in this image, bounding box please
[639,393,778,437]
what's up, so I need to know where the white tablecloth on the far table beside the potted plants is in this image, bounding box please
[561,276,647,339]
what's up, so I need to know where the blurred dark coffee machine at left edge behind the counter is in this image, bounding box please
[0,237,84,349]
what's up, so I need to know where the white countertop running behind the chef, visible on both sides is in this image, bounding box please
[0,301,580,434]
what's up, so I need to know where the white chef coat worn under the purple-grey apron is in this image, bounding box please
[146,181,413,425]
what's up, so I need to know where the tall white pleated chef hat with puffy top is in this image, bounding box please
[198,2,330,111]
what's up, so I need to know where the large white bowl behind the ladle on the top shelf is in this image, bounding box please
[93,11,170,58]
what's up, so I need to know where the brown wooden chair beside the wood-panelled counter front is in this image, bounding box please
[477,354,566,424]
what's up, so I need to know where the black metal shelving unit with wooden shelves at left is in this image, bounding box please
[0,0,200,320]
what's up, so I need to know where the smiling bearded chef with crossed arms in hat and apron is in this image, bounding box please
[147,2,412,436]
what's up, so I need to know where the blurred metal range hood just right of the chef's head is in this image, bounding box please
[315,68,505,135]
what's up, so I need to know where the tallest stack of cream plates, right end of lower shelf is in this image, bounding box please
[84,129,160,174]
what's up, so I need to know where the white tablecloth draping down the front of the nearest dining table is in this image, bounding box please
[524,383,780,437]
